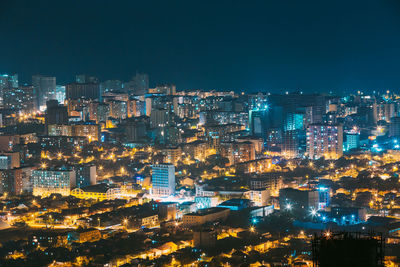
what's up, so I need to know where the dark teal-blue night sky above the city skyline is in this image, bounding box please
[0,0,400,91]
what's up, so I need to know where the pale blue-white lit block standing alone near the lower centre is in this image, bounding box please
[152,164,175,196]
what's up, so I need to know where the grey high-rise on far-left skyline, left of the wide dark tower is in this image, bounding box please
[32,75,57,108]
